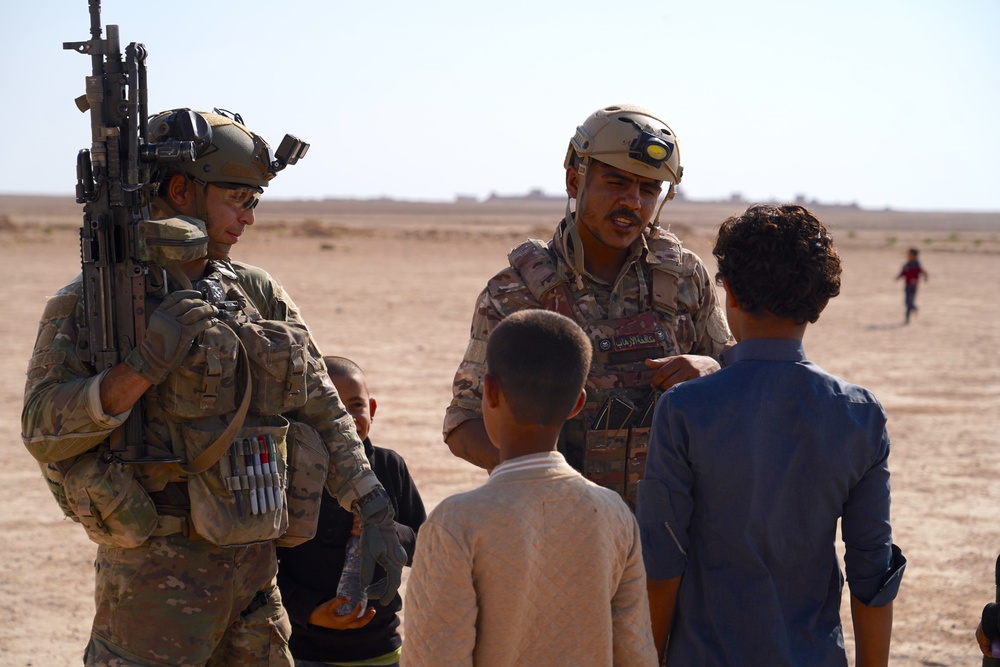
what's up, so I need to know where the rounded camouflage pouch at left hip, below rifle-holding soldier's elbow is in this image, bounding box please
[63,452,158,548]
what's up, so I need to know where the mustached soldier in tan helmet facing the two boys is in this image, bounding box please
[444,105,733,508]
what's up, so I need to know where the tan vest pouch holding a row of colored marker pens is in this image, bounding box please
[180,416,288,547]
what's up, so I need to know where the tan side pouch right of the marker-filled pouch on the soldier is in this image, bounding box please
[277,421,330,547]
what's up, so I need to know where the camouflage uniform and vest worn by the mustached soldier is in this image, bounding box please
[444,221,733,504]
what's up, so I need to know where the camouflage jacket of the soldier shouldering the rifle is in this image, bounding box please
[21,262,378,507]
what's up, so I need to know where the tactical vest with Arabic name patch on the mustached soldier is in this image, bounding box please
[508,234,683,510]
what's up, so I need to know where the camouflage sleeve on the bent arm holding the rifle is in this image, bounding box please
[21,278,129,463]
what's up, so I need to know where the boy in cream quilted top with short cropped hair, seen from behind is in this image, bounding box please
[402,310,656,667]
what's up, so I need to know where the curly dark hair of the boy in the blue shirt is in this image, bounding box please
[712,204,840,324]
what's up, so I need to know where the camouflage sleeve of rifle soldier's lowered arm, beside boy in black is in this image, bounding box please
[239,265,379,511]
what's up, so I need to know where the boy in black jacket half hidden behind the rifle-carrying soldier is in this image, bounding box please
[278,357,427,667]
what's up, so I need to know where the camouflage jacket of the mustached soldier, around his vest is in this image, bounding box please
[443,221,734,446]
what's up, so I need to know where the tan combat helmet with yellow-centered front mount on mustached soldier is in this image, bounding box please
[563,104,684,193]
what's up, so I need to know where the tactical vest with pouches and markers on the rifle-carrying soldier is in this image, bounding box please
[50,264,324,547]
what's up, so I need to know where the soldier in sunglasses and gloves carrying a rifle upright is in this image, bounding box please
[22,110,406,666]
